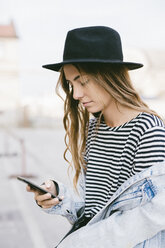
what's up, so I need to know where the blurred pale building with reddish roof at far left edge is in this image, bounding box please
[0,19,20,126]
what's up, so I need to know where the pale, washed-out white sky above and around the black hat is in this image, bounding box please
[0,0,165,96]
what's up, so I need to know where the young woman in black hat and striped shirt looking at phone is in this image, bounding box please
[27,26,165,248]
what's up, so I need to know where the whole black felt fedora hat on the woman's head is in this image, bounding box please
[43,26,143,71]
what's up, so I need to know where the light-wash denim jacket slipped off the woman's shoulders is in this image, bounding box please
[46,162,165,248]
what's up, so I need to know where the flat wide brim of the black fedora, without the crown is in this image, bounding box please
[42,59,143,72]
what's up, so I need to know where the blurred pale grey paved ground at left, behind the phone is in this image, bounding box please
[0,128,70,248]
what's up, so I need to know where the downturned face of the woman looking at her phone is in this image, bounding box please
[64,64,114,114]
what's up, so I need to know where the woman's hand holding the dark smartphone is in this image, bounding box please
[26,180,63,208]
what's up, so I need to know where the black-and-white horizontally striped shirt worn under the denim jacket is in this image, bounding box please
[85,113,165,217]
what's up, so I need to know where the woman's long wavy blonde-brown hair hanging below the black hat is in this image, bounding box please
[56,63,159,188]
